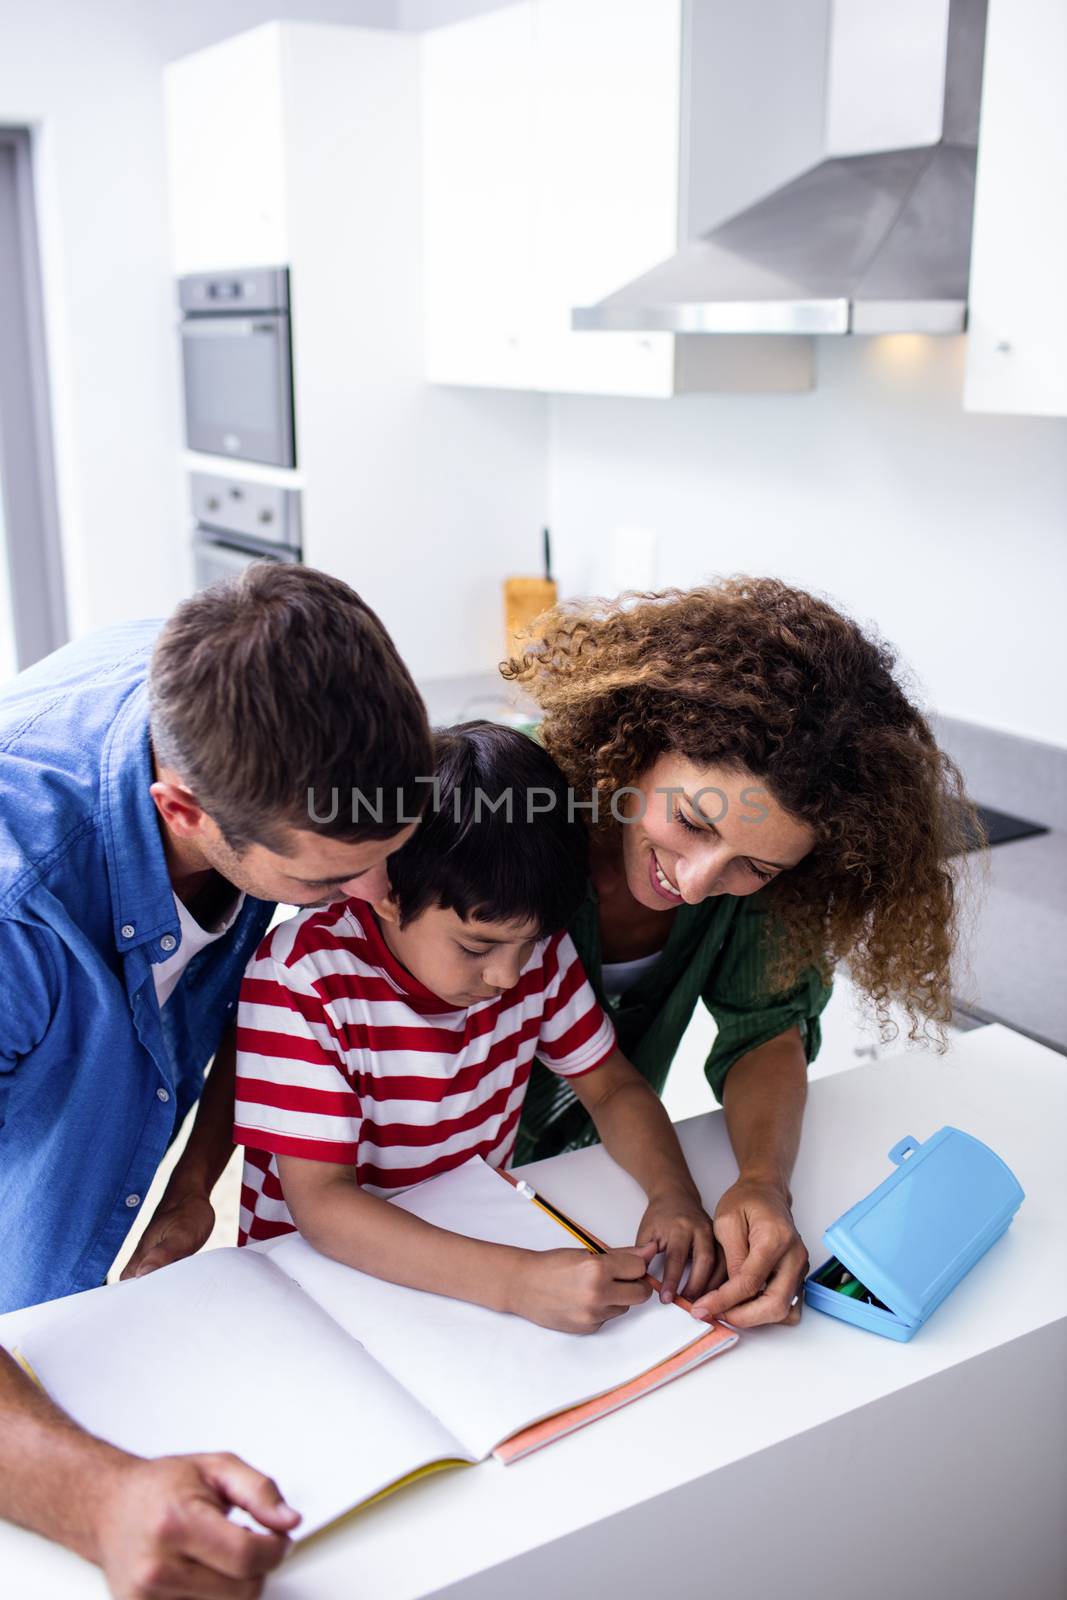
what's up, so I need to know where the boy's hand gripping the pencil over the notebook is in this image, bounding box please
[507,1242,656,1333]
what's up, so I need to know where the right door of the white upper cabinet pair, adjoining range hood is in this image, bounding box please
[534,0,681,395]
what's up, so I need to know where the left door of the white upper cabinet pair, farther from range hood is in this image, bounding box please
[422,0,537,389]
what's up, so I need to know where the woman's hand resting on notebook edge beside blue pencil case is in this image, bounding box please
[693,1178,808,1328]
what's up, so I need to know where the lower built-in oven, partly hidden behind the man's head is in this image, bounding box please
[189,472,301,589]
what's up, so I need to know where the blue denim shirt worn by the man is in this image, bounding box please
[0,622,274,1310]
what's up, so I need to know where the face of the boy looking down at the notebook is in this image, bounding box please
[373,899,539,1011]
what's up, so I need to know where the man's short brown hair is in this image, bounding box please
[149,562,434,850]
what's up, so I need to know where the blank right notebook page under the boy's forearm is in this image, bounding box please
[270,1157,707,1458]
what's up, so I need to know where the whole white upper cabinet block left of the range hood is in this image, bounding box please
[422,0,811,395]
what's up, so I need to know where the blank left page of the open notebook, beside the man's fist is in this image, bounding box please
[21,1250,464,1538]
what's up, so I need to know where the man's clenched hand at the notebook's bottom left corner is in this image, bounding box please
[83,1453,301,1600]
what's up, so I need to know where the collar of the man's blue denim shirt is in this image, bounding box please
[101,683,179,952]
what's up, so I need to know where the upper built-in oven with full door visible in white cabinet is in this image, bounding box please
[178,267,296,467]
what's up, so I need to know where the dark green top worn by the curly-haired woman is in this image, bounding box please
[515,885,830,1163]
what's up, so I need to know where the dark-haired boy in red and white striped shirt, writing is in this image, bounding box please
[234,723,715,1333]
